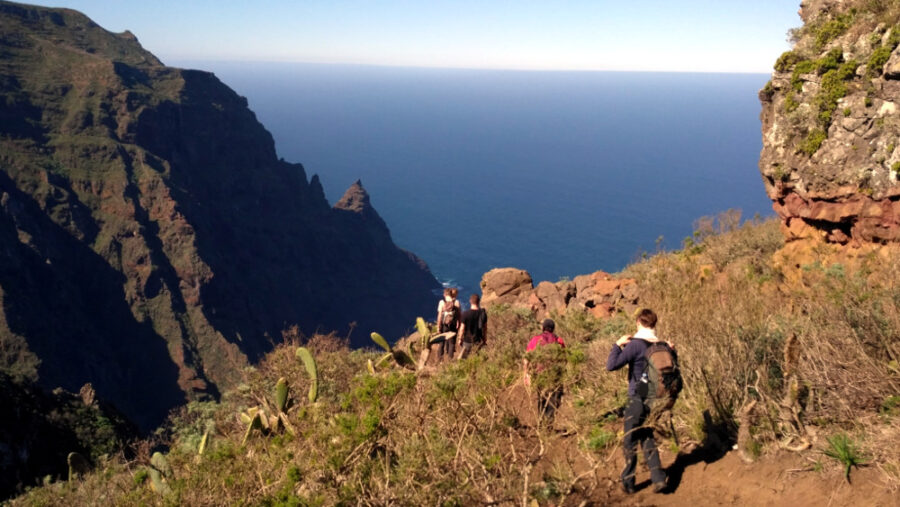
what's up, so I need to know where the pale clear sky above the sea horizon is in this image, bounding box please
[26,0,801,73]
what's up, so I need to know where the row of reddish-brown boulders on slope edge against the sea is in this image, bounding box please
[481,268,639,318]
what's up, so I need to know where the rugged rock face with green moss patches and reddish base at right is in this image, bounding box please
[759,0,900,244]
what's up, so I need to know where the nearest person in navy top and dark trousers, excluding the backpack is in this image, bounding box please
[606,309,671,494]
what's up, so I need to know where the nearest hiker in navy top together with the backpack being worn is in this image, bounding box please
[606,309,681,494]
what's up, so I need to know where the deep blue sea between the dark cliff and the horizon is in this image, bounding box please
[175,62,772,297]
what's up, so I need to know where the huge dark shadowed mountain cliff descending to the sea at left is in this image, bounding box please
[0,2,438,427]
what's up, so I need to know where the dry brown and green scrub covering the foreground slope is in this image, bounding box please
[14,213,900,505]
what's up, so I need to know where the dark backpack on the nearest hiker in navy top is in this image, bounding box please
[642,342,684,424]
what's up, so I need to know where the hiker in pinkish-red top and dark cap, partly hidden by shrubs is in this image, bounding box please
[522,319,566,423]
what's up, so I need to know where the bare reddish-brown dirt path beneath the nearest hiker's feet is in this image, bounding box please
[506,384,900,507]
